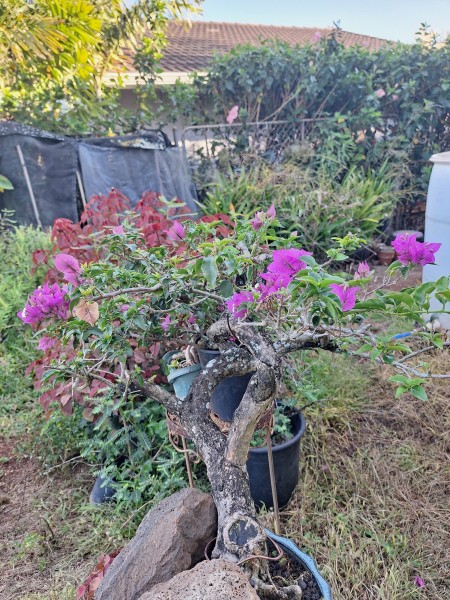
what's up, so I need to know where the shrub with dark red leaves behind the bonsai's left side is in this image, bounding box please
[27,189,192,421]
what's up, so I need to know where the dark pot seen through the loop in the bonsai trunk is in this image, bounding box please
[197,348,253,422]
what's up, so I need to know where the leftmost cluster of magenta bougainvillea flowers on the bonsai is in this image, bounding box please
[17,283,69,324]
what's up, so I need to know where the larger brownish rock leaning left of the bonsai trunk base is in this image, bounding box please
[95,488,217,600]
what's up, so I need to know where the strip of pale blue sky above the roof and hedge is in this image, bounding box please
[194,0,450,42]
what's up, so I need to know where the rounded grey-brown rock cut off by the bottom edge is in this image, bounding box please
[140,559,259,600]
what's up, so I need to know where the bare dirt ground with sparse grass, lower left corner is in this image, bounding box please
[0,438,91,600]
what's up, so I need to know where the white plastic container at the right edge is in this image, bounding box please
[422,152,450,329]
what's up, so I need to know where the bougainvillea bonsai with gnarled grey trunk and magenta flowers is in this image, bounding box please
[19,207,450,598]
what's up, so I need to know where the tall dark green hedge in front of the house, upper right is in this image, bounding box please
[169,30,450,223]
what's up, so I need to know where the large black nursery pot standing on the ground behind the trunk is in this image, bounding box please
[247,414,306,508]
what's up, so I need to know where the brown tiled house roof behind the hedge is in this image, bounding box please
[161,21,389,73]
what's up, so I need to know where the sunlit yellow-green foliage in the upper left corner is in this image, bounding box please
[0,0,202,134]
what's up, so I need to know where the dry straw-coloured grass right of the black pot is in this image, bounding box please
[264,357,450,600]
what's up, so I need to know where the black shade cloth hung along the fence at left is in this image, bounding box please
[0,121,197,227]
